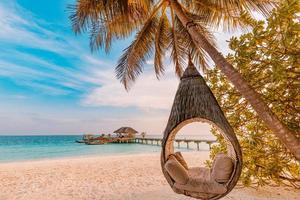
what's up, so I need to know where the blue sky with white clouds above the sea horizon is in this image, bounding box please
[0,0,240,135]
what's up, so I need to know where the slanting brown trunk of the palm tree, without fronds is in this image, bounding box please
[170,0,300,160]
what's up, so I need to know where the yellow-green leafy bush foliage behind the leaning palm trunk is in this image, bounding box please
[207,0,300,187]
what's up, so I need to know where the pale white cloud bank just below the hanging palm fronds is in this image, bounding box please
[82,65,179,109]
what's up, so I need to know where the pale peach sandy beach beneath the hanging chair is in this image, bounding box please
[0,152,300,200]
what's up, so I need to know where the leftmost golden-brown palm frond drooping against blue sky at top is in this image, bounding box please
[69,0,153,52]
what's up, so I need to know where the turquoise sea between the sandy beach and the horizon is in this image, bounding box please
[0,135,216,163]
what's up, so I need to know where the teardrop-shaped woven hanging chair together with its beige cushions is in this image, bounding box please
[161,61,242,199]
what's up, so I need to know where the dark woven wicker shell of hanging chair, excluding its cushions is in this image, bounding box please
[161,62,242,199]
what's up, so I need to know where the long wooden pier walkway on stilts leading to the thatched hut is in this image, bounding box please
[134,138,217,150]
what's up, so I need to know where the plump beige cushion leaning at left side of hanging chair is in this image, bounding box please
[165,154,189,184]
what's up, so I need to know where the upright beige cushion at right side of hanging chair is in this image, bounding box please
[211,153,233,183]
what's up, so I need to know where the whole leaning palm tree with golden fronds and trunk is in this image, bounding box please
[70,0,300,160]
